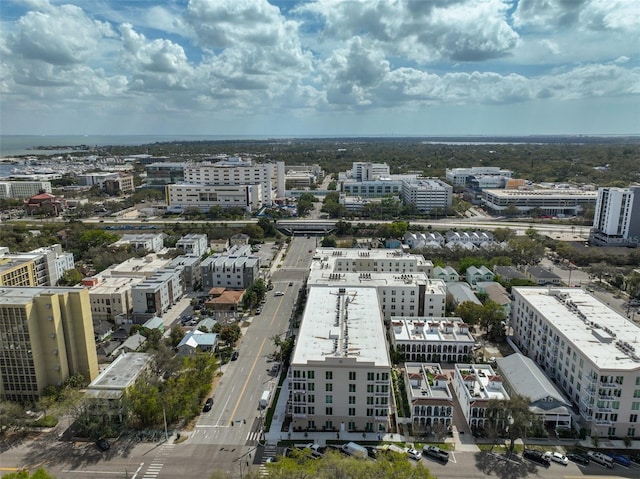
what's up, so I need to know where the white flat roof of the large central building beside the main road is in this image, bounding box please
[292,286,390,367]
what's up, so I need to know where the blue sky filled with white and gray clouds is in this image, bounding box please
[0,0,640,137]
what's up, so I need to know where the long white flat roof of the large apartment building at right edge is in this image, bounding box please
[513,287,640,370]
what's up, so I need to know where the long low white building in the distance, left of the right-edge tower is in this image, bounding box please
[482,188,597,216]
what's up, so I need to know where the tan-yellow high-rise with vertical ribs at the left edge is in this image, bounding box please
[0,287,98,405]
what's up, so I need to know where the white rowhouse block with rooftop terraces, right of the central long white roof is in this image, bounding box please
[390,316,475,363]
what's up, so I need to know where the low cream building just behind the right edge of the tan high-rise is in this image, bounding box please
[82,274,144,324]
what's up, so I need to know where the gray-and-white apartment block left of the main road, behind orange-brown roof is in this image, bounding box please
[200,245,260,291]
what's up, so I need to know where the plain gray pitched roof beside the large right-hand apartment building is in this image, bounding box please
[496,353,570,411]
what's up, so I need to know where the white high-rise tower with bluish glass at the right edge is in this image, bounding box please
[590,186,640,246]
